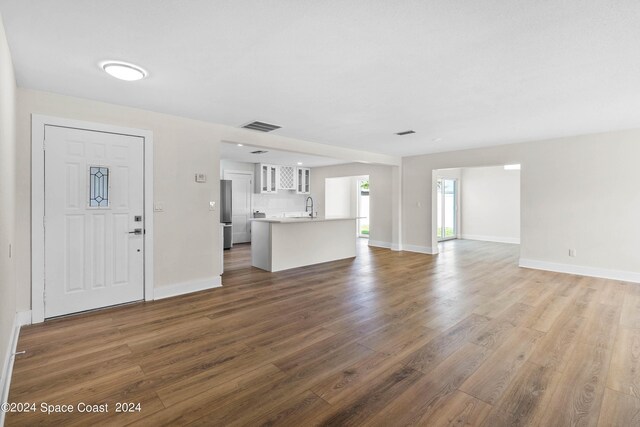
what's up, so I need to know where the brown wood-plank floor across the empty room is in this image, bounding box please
[6,241,640,426]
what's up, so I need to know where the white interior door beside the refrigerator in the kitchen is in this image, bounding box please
[224,172,253,243]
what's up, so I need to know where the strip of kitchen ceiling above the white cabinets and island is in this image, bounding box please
[220,142,349,168]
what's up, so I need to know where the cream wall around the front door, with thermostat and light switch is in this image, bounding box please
[16,89,222,310]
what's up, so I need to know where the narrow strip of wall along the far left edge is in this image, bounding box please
[0,10,17,404]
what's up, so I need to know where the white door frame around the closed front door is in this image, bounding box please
[31,114,153,323]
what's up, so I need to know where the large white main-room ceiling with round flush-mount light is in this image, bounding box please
[0,0,640,156]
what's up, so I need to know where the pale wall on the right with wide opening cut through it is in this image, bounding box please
[402,129,640,281]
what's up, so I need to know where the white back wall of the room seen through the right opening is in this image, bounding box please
[460,166,520,243]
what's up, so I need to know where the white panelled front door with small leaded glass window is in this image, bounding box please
[44,125,144,318]
